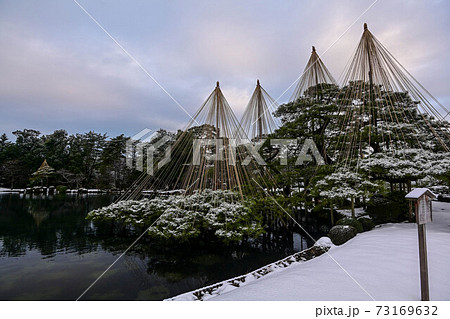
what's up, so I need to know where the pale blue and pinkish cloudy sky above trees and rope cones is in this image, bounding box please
[0,0,450,136]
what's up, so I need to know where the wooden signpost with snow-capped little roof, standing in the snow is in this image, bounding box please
[405,188,436,301]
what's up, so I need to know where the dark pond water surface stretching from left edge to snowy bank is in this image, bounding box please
[0,193,308,300]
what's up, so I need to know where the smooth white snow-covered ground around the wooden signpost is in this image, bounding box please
[205,202,450,300]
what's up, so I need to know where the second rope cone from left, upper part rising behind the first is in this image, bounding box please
[241,80,278,140]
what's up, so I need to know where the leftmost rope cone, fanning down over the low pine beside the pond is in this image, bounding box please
[119,82,271,200]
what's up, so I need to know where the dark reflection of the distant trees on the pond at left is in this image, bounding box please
[0,194,107,257]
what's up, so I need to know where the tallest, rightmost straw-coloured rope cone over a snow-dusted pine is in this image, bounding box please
[328,24,450,168]
